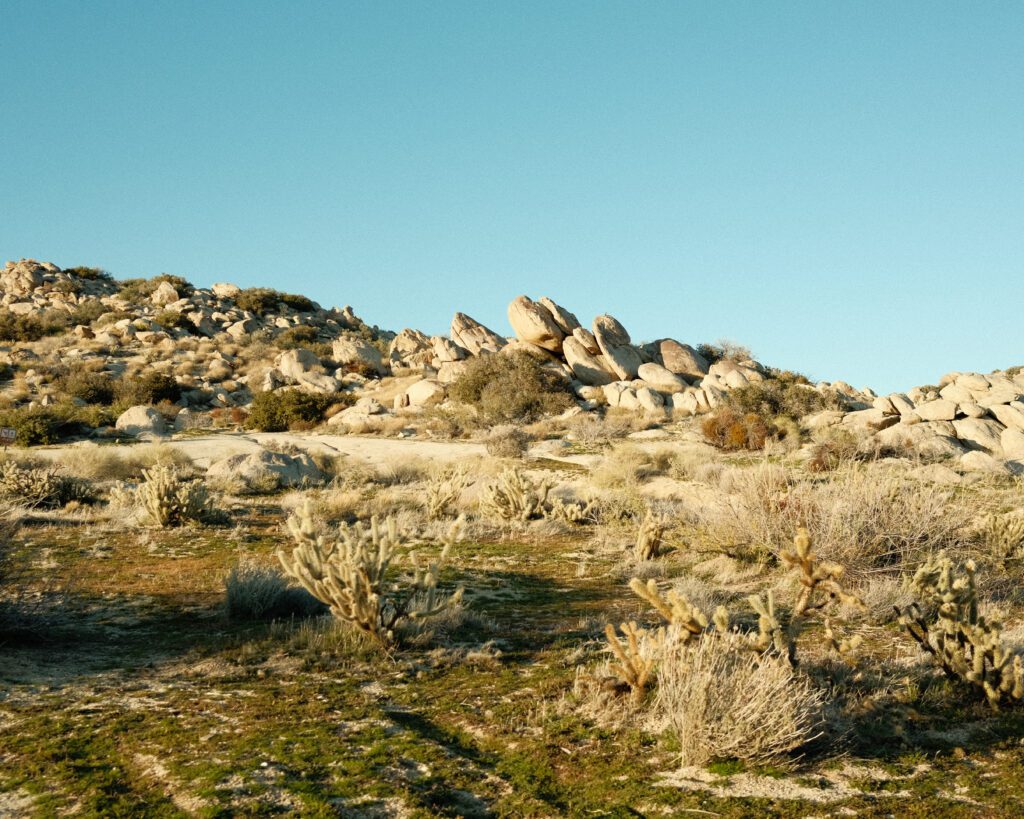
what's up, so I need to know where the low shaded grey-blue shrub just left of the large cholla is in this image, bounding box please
[224,558,325,620]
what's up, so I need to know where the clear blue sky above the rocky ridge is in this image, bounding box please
[0,0,1024,390]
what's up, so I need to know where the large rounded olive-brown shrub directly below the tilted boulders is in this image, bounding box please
[449,353,573,424]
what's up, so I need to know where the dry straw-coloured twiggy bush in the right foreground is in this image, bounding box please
[654,635,823,766]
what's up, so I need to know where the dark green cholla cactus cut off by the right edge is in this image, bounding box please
[897,552,1024,710]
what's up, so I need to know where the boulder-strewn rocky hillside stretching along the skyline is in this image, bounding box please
[0,259,1024,471]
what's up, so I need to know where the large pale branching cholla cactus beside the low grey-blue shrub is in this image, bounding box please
[276,501,463,644]
